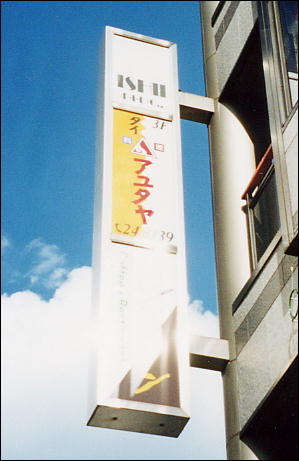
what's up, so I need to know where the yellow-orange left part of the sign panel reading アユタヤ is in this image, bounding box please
[112,109,154,237]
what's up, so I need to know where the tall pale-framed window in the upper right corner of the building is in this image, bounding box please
[255,1,298,260]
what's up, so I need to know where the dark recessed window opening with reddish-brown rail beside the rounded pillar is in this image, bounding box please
[220,23,280,270]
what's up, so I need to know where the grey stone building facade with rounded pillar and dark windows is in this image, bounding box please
[200,1,298,459]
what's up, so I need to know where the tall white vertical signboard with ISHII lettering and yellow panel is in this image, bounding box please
[88,27,189,437]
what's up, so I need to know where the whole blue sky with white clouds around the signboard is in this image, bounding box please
[1,1,225,459]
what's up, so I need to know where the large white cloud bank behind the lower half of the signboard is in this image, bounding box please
[1,266,226,460]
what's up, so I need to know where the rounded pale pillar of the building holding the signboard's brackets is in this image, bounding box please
[200,1,257,460]
